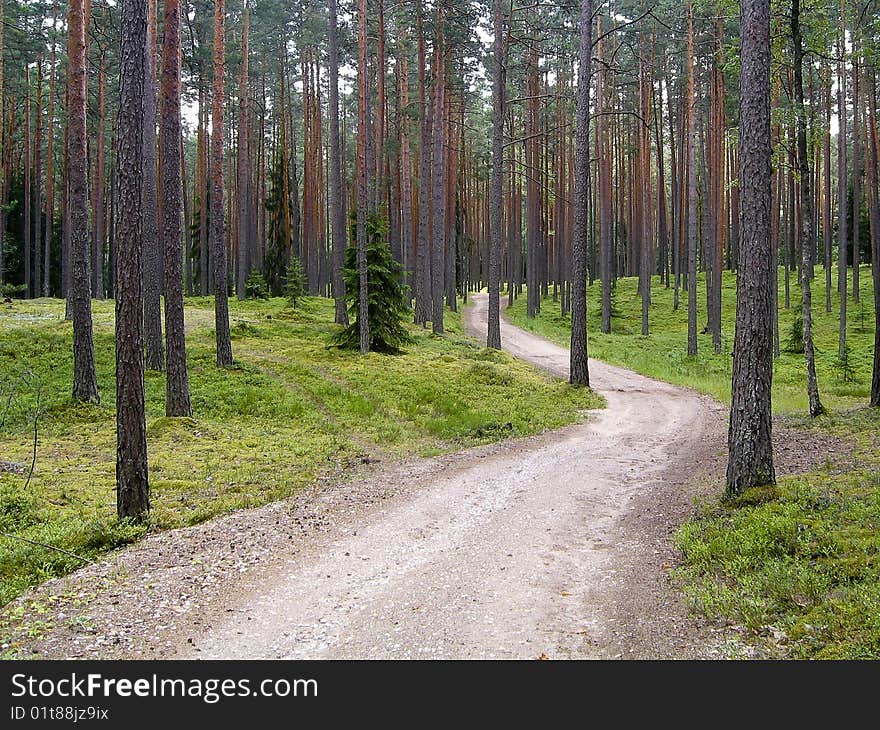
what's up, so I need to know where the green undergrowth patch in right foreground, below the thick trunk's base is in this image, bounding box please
[675,409,880,659]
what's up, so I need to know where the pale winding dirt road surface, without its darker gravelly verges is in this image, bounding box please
[172,296,720,658]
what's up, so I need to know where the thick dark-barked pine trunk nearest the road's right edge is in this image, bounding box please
[726,0,776,498]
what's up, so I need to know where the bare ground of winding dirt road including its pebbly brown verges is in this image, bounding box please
[0,290,846,658]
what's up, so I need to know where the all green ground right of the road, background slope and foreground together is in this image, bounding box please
[508,267,880,659]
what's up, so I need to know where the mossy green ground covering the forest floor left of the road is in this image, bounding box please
[0,298,601,605]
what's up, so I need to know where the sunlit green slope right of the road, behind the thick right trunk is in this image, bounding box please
[507,265,874,414]
